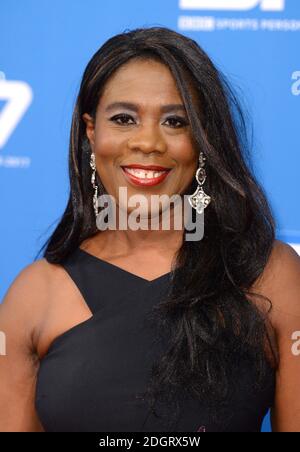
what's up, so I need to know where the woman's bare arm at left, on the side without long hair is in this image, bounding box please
[0,260,47,432]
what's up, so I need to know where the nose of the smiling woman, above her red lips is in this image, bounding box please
[128,124,167,153]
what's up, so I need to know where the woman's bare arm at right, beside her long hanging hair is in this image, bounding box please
[252,240,300,432]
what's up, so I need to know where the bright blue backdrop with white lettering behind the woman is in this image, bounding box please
[0,0,300,431]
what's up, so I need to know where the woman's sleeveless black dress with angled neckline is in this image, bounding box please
[35,248,275,432]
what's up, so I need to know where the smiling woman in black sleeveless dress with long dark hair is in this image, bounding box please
[0,28,300,432]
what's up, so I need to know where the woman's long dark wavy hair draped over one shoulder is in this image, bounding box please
[39,27,276,430]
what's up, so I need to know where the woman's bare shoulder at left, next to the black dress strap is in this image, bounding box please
[0,254,92,360]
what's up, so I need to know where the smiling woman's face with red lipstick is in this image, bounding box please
[83,60,198,214]
